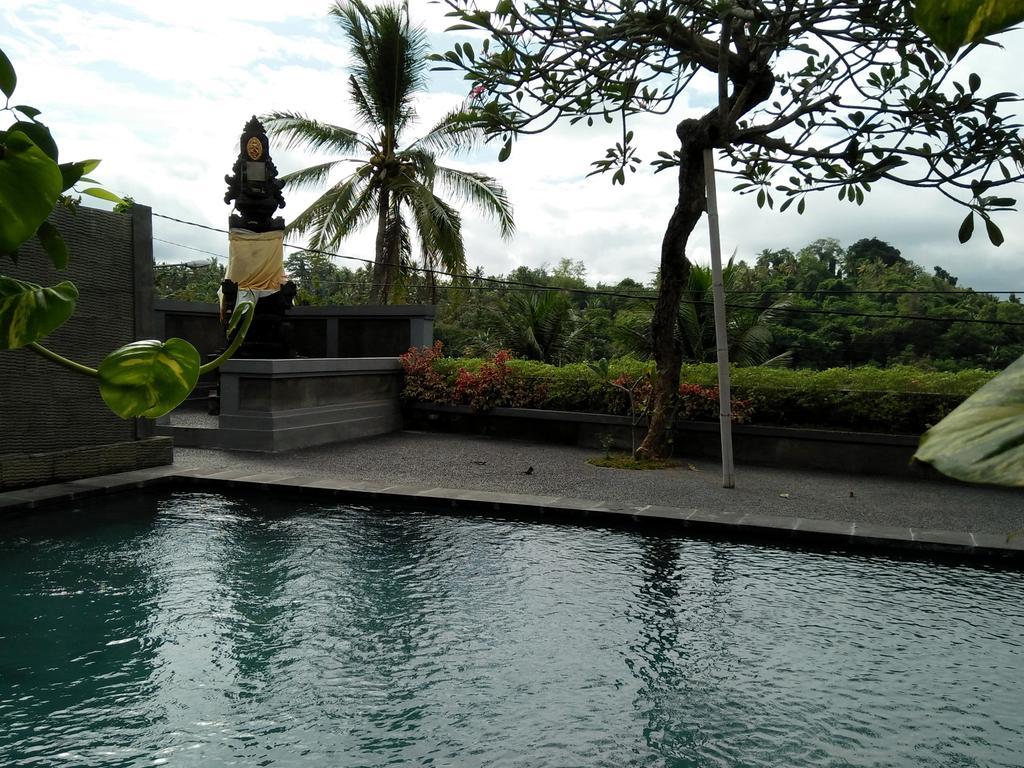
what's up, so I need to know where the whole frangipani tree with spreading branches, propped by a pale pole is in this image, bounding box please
[435,0,1024,457]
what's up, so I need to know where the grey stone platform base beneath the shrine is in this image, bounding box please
[157,357,401,453]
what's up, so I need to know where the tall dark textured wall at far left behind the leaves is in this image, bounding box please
[0,206,153,456]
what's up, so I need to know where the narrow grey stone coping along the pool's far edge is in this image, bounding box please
[0,465,1024,562]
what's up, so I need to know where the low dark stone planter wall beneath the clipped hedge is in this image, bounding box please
[402,403,936,477]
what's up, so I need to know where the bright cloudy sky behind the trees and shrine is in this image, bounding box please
[0,0,1024,292]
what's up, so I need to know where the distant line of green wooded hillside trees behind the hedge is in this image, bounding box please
[156,239,1024,371]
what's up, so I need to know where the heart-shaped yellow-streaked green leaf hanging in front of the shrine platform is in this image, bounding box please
[98,339,200,419]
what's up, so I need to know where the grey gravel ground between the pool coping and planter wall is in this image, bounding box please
[174,432,1024,534]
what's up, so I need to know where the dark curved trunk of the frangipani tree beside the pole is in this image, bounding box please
[636,117,714,459]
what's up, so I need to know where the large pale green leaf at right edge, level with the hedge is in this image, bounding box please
[913,357,1024,486]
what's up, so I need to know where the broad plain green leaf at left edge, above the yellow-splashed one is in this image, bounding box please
[0,131,60,253]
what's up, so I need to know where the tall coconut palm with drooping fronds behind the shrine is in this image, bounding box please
[264,0,514,303]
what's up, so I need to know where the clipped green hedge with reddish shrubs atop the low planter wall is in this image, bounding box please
[403,349,995,434]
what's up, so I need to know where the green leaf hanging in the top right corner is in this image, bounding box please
[913,0,1024,57]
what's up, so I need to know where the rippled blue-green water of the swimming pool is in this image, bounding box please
[0,494,1024,768]
